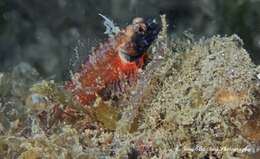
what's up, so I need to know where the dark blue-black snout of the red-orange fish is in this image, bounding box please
[133,18,161,55]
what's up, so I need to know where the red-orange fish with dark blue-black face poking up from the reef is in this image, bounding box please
[66,17,161,105]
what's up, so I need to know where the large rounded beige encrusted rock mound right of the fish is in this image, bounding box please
[136,35,260,158]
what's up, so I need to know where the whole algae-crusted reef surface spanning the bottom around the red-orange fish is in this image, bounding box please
[0,21,260,159]
